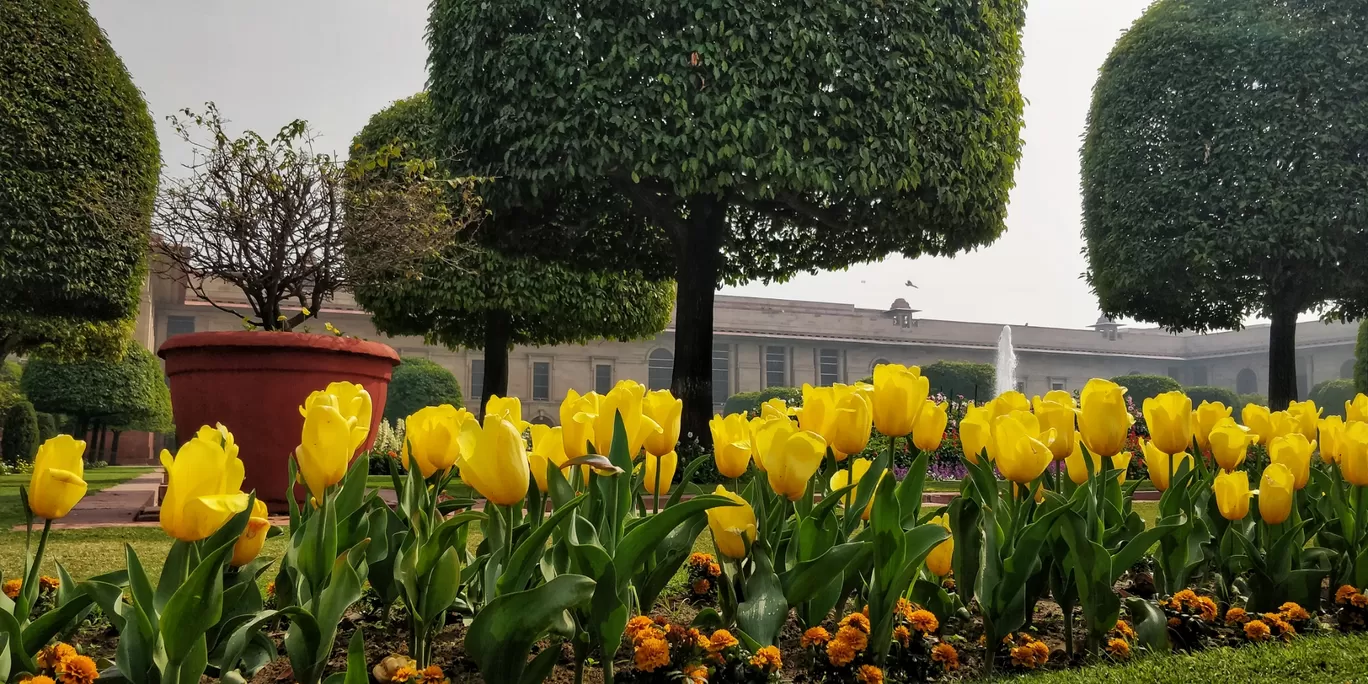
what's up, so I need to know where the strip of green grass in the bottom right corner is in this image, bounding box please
[1000,635,1368,684]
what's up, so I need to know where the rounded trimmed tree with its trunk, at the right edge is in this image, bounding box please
[1082,0,1368,409]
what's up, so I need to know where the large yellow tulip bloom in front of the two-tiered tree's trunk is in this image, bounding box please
[460,409,531,506]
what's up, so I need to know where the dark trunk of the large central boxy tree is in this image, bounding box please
[670,196,726,447]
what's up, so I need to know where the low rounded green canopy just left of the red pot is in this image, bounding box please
[19,342,172,432]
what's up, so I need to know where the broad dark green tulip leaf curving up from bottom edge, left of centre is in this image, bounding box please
[465,575,594,683]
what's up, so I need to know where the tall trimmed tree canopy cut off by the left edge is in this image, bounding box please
[0,0,161,357]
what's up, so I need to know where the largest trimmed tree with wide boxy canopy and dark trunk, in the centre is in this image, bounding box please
[428,0,1025,436]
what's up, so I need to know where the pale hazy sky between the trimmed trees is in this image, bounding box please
[90,0,1150,327]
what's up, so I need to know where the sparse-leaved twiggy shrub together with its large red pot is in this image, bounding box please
[153,104,473,508]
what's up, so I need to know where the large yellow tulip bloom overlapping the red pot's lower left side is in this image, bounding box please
[160,424,248,542]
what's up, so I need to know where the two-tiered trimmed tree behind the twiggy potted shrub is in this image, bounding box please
[347,93,674,397]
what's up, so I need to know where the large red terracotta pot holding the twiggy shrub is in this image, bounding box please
[157,331,399,510]
